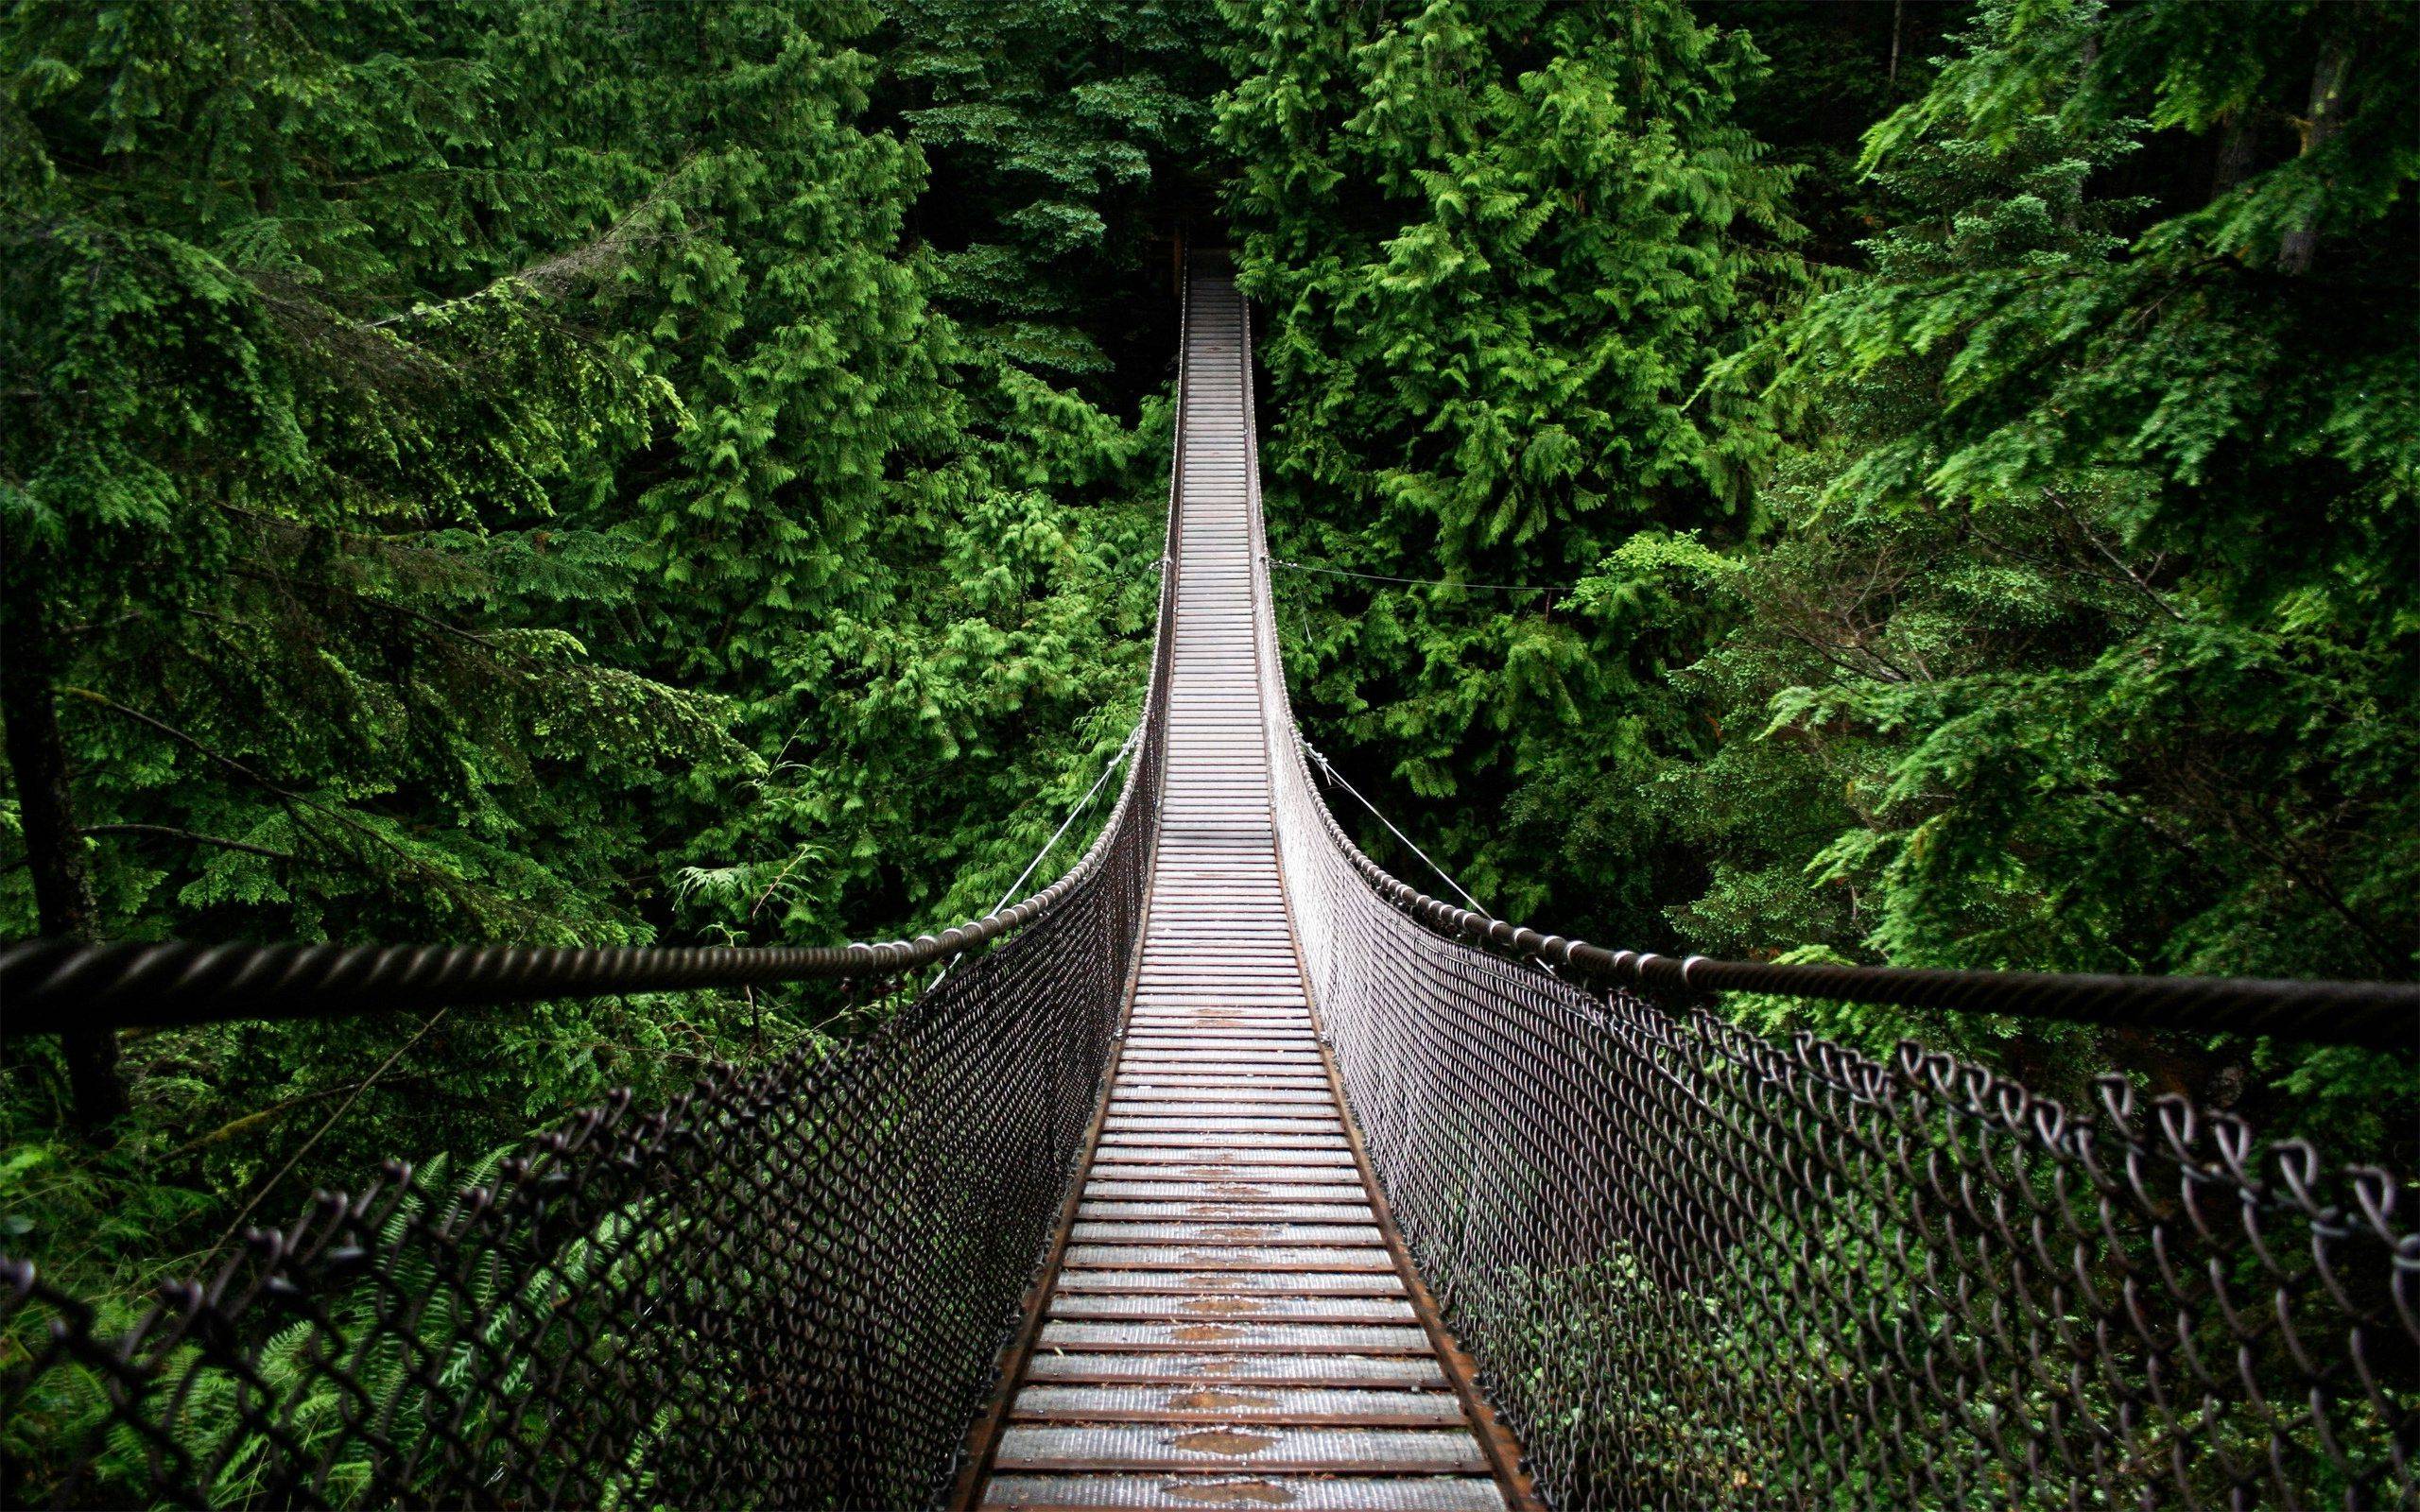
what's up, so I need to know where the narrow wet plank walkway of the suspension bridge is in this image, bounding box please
[980,271,1520,1512]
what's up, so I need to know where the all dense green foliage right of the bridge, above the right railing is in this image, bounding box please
[1222,0,2420,1132]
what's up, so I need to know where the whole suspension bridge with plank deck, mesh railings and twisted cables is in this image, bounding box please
[0,253,2420,1512]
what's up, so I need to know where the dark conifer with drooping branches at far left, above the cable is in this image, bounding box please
[0,5,743,1137]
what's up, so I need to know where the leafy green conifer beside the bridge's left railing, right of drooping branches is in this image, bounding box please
[576,5,1181,941]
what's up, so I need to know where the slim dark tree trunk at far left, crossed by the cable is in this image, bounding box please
[0,574,129,1126]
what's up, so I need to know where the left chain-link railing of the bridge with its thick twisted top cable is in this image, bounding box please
[0,456,1174,1509]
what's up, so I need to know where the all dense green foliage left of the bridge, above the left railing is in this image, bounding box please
[0,0,1200,1297]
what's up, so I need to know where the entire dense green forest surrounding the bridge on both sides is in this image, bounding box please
[0,0,2420,1325]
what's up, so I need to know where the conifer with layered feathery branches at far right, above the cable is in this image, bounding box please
[1598,3,2420,1127]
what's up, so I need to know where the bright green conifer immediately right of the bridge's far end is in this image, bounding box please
[1219,0,1789,934]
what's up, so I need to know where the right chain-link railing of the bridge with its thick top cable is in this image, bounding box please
[1253,301,2420,1512]
